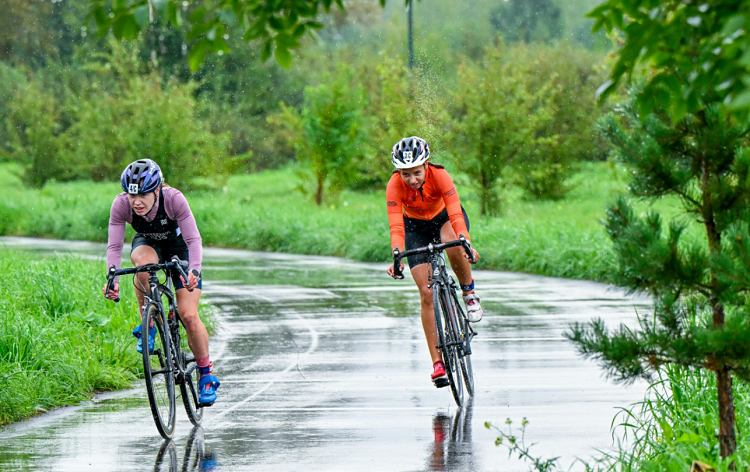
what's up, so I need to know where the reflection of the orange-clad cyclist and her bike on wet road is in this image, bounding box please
[425,398,475,471]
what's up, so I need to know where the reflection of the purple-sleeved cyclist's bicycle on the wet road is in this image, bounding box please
[154,425,218,472]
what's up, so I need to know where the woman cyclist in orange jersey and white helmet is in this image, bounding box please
[386,136,483,387]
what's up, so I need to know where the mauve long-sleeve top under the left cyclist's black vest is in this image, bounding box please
[107,186,203,278]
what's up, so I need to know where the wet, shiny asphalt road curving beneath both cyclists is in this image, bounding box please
[0,238,648,472]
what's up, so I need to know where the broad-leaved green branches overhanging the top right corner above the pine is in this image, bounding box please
[589,0,750,122]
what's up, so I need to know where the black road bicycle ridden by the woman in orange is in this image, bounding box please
[393,235,476,406]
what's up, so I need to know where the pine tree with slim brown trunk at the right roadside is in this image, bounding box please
[567,94,750,457]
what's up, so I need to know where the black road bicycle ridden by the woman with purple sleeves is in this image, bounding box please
[107,256,204,439]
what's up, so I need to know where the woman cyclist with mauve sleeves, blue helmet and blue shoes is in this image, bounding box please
[104,159,220,404]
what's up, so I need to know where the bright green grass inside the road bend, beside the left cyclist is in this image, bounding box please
[0,248,215,425]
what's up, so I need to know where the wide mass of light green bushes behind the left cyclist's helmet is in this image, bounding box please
[0,43,234,187]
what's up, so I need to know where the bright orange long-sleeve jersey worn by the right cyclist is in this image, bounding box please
[385,165,471,250]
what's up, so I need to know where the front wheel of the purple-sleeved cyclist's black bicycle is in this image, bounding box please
[141,304,176,439]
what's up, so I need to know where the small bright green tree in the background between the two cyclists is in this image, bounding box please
[272,68,369,205]
